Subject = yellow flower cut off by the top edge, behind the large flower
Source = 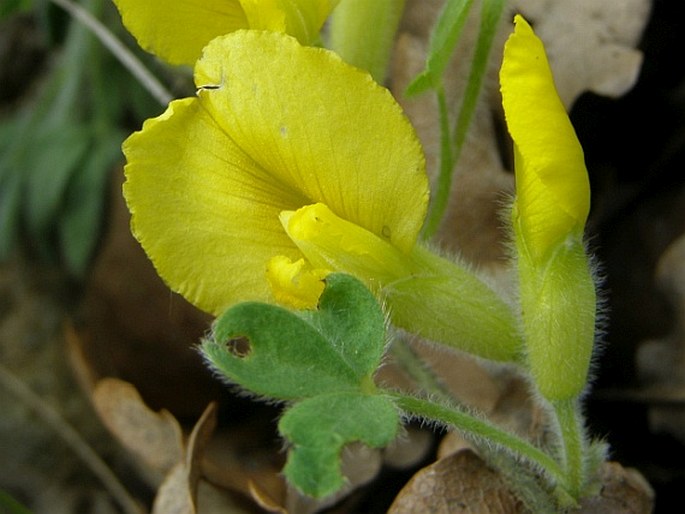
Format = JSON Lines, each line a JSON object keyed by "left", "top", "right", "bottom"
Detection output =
{"left": 114, "top": 0, "right": 339, "bottom": 65}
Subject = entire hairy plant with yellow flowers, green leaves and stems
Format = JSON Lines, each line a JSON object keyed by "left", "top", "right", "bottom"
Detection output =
{"left": 116, "top": 0, "right": 604, "bottom": 507}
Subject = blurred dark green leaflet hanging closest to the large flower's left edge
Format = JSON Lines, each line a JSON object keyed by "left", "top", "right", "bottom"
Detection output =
{"left": 58, "top": 131, "right": 123, "bottom": 277}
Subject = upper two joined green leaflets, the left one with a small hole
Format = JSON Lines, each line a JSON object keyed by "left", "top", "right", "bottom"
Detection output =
{"left": 201, "top": 274, "right": 385, "bottom": 400}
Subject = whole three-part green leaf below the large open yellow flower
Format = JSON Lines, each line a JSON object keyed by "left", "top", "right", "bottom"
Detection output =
{"left": 202, "top": 273, "right": 400, "bottom": 497}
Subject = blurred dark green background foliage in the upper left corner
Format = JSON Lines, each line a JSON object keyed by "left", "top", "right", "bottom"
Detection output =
{"left": 0, "top": 0, "right": 162, "bottom": 278}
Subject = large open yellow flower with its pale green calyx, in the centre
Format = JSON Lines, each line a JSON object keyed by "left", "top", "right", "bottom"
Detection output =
{"left": 124, "top": 31, "right": 520, "bottom": 360}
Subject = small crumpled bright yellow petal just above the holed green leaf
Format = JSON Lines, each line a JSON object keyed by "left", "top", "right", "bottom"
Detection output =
{"left": 266, "top": 255, "right": 328, "bottom": 309}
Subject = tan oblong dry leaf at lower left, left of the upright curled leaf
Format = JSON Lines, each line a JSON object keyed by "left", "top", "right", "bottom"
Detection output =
{"left": 93, "top": 378, "right": 184, "bottom": 484}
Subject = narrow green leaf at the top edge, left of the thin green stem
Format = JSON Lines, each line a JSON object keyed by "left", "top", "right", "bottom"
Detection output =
{"left": 406, "top": 0, "right": 473, "bottom": 96}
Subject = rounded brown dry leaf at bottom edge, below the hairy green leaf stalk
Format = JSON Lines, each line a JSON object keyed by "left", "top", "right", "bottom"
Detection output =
{"left": 388, "top": 449, "right": 524, "bottom": 514}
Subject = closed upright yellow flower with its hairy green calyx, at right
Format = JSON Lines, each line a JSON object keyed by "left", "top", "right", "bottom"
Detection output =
{"left": 500, "top": 16, "right": 596, "bottom": 401}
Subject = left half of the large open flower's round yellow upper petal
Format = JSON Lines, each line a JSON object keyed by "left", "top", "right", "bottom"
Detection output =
{"left": 124, "top": 99, "right": 302, "bottom": 313}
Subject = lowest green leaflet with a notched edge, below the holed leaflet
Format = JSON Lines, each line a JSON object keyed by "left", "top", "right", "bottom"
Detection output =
{"left": 278, "top": 392, "right": 399, "bottom": 498}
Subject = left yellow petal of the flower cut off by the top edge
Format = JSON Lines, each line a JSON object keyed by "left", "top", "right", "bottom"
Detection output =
{"left": 114, "top": 0, "right": 248, "bottom": 65}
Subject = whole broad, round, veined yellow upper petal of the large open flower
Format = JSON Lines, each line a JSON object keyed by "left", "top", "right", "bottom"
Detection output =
{"left": 124, "top": 31, "right": 427, "bottom": 314}
